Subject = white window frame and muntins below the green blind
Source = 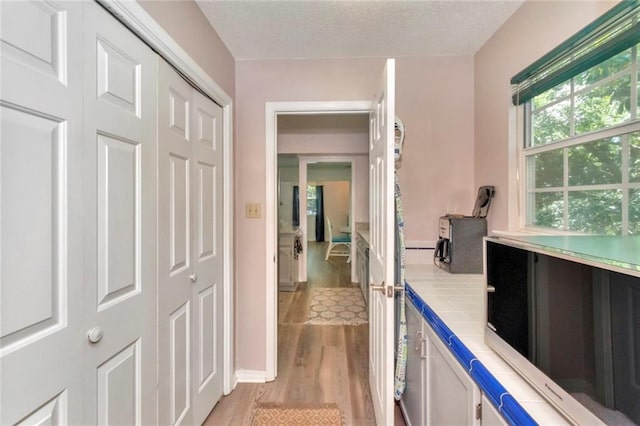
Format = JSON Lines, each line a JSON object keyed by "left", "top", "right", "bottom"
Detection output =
{"left": 510, "top": 45, "right": 640, "bottom": 235}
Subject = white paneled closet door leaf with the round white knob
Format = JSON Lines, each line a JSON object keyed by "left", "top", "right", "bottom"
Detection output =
{"left": 83, "top": 2, "right": 157, "bottom": 425}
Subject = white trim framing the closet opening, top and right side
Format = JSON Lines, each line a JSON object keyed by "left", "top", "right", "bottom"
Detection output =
{"left": 96, "top": 0, "right": 237, "bottom": 395}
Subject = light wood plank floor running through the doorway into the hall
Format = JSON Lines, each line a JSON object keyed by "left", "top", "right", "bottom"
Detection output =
{"left": 204, "top": 243, "right": 405, "bottom": 426}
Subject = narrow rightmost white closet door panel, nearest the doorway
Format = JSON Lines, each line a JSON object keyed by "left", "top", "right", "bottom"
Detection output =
{"left": 191, "top": 90, "right": 223, "bottom": 424}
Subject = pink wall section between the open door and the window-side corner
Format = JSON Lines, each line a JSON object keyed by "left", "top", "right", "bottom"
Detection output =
{"left": 396, "top": 56, "right": 476, "bottom": 243}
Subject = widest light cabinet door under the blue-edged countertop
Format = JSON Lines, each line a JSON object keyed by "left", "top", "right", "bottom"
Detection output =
{"left": 425, "top": 326, "right": 480, "bottom": 426}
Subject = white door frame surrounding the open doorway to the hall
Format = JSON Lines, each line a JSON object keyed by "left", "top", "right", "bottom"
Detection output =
{"left": 264, "top": 101, "right": 371, "bottom": 381}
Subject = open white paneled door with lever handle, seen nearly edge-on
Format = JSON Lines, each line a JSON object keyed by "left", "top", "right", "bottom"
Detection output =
{"left": 369, "top": 59, "right": 395, "bottom": 425}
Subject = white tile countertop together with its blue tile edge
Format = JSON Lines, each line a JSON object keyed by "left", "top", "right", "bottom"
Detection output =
{"left": 405, "top": 264, "right": 568, "bottom": 425}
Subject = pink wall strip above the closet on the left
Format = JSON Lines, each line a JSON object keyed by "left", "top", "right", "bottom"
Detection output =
{"left": 138, "top": 0, "right": 235, "bottom": 98}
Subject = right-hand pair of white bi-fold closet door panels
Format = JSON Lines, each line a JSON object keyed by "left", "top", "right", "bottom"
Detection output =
{"left": 158, "top": 60, "right": 223, "bottom": 424}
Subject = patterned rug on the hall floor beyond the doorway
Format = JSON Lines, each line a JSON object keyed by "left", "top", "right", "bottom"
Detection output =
{"left": 305, "top": 287, "right": 369, "bottom": 325}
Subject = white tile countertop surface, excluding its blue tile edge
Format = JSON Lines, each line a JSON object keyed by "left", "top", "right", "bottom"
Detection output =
{"left": 405, "top": 264, "right": 568, "bottom": 425}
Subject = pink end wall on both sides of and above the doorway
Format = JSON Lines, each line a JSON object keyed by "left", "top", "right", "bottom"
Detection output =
{"left": 235, "top": 57, "right": 475, "bottom": 370}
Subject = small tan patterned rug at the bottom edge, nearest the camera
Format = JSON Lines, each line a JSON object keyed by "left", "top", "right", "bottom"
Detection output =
{"left": 251, "top": 402, "right": 343, "bottom": 426}
